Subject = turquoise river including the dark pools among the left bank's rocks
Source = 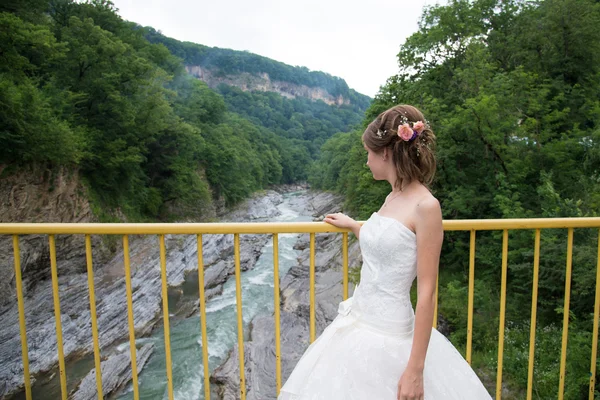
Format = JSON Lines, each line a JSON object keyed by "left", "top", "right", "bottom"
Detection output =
{"left": 10, "top": 191, "right": 312, "bottom": 400}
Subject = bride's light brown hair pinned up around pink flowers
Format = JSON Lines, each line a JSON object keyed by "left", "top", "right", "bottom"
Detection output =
{"left": 362, "top": 104, "right": 436, "bottom": 189}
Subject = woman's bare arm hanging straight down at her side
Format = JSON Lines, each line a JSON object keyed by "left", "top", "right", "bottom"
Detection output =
{"left": 398, "top": 197, "right": 444, "bottom": 399}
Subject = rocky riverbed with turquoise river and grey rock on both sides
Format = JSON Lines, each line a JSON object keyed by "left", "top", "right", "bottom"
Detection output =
{"left": 0, "top": 191, "right": 358, "bottom": 399}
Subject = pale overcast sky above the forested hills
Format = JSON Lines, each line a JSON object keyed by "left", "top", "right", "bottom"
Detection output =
{"left": 112, "top": 0, "right": 445, "bottom": 97}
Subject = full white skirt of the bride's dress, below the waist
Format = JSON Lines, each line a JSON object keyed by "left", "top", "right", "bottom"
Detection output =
{"left": 278, "top": 299, "right": 491, "bottom": 400}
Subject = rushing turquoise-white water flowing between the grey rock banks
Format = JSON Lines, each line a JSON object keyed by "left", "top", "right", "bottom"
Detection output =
{"left": 119, "top": 193, "right": 311, "bottom": 400}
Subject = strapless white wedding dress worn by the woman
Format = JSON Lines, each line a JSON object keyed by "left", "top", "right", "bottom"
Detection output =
{"left": 278, "top": 213, "right": 491, "bottom": 400}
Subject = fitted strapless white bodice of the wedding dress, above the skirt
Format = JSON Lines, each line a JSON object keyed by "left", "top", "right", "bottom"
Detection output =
{"left": 352, "top": 213, "right": 417, "bottom": 332}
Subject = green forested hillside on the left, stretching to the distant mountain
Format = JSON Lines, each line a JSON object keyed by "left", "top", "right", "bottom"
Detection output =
{"left": 0, "top": 0, "right": 369, "bottom": 221}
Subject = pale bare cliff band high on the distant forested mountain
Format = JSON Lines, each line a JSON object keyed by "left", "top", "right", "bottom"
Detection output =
{"left": 185, "top": 65, "right": 350, "bottom": 106}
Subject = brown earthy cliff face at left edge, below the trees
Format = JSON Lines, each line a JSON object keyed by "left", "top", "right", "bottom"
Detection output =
{"left": 0, "top": 165, "right": 108, "bottom": 306}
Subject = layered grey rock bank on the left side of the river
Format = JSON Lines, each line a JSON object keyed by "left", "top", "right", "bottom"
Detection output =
{"left": 0, "top": 189, "right": 310, "bottom": 398}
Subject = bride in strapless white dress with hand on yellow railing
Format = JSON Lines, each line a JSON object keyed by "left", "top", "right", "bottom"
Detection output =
{"left": 278, "top": 105, "right": 491, "bottom": 400}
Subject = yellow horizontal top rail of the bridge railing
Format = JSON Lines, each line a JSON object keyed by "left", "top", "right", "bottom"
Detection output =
{"left": 0, "top": 217, "right": 600, "bottom": 235}
